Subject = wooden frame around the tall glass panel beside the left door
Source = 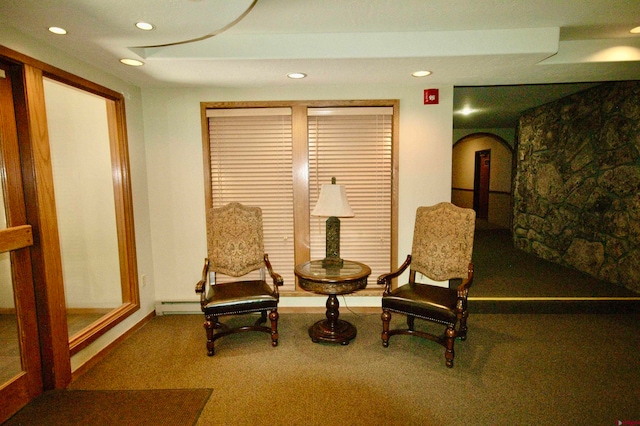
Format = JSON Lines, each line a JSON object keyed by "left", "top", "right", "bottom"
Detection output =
{"left": 0, "top": 45, "right": 140, "bottom": 398}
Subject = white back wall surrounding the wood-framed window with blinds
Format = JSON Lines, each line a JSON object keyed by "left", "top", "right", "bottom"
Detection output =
{"left": 143, "top": 86, "right": 453, "bottom": 306}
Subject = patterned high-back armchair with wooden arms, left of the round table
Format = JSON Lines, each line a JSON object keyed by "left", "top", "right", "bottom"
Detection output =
{"left": 196, "top": 203, "right": 283, "bottom": 356}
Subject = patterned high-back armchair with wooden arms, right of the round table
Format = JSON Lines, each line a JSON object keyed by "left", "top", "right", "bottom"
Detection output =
{"left": 378, "top": 203, "right": 475, "bottom": 367}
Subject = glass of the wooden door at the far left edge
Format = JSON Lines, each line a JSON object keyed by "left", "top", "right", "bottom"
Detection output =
{"left": 0, "top": 181, "right": 22, "bottom": 385}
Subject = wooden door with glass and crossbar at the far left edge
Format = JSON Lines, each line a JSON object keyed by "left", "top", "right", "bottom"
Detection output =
{"left": 0, "top": 62, "right": 43, "bottom": 423}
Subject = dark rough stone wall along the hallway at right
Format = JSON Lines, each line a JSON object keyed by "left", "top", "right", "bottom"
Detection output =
{"left": 513, "top": 81, "right": 640, "bottom": 293}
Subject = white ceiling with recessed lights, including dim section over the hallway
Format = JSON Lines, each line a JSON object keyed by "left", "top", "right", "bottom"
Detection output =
{"left": 0, "top": 0, "right": 640, "bottom": 128}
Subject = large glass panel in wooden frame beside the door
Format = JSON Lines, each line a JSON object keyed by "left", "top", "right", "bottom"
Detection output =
{"left": 44, "top": 79, "right": 123, "bottom": 336}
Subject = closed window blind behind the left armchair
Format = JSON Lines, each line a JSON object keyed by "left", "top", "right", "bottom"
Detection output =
{"left": 207, "top": 108, "right": 295, "bottom": 290}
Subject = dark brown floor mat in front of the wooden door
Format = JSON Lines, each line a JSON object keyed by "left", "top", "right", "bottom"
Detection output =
{"left": 5, "top": 389, "right": 211, "bottom": 426}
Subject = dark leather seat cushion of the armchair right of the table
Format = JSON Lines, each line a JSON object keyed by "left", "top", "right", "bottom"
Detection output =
{"left": 382, "top": 283, "right": 458, "bottom": 324}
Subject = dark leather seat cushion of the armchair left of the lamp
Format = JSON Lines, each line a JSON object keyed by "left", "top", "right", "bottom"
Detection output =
{"left": 204, "top": 281, "right": 278, "bottom": 315}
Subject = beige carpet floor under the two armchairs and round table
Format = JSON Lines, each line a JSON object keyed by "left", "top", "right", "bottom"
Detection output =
{"left": 61, "top": 312, "right": 640, "bottom": 426}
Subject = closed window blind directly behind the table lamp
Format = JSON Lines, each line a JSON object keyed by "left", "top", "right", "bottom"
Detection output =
{"left": 308, "top": 107, "right": 393, "bottom": 282}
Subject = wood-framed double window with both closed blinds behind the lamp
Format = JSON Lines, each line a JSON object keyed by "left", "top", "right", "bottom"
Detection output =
{"left": 202, "top": 101, "right": 397, "bottom": 291}
